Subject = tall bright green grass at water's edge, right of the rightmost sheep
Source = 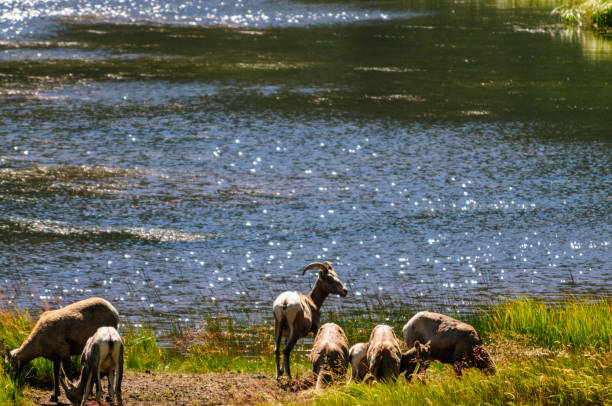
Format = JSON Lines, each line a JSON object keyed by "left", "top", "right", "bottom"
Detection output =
{"left": 479, "top": 297, "right": 612, "bottom": 351}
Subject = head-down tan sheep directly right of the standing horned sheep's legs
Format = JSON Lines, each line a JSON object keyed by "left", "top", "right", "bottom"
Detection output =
{"left": 310, "top": 323, "right": 348, "bottom": 389}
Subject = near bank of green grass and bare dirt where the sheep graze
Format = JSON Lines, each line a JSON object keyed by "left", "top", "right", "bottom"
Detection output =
{"left": 0, "top": 297, "right": 612, "bottom": 405}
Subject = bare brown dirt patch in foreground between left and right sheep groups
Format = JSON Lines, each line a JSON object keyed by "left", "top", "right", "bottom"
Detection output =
{"left": 24, "top": 371, "right": 312, "bottom": 406}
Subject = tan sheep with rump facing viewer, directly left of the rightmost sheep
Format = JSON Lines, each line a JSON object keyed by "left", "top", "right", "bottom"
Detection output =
{"left": 366, "top": 324, "right": 402, "bottom": 381}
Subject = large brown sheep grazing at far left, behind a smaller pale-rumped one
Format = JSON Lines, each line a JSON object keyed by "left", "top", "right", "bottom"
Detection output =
{"left": 6, "top": 297, "right": 119, "bottom": 402}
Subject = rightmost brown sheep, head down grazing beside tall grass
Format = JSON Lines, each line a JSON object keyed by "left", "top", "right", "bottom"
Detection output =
{"left": 402, "top": 312, "right": 495, "bottom": 376}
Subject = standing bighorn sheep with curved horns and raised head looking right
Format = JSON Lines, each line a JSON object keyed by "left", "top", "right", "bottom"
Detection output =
{"left": 272, "top": 262, "right": 348, "bottom": 379}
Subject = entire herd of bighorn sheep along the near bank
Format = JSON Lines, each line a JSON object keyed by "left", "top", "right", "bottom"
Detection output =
{"left": 1, "top": 262, "right": 495, "bottom": 406}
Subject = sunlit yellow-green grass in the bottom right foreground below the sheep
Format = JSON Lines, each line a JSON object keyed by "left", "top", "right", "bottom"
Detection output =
{"left": 313, "top": 353, "right": 612, "bottom": 406}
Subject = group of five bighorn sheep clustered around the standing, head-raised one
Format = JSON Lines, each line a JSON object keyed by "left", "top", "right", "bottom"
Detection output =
{"left": 272, "top": 262, "right": 495, "bottom": 388}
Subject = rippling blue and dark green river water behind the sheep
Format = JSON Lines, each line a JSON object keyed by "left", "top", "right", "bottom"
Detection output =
{"left": 0, "top": 0, "right": 612, "bottom": 325}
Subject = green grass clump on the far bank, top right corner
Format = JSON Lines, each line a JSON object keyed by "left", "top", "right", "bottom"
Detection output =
{"left": 553, "top": 0, "right": 612, "bottom": 30}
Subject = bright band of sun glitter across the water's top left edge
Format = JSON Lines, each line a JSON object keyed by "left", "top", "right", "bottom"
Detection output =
{"left": 0, "top": 0, "right": 417, "bottom": 39}
